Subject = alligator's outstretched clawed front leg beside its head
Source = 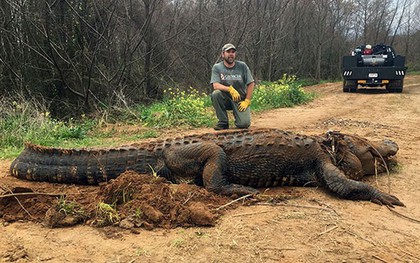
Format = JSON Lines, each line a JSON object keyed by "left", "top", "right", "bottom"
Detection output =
{"left": 318, "top": 162, "right": 404, "bottom": 207}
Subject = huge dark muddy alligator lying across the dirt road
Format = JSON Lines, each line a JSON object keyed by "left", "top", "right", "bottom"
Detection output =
{"left": 10, "top": 129, "right": 404, "bottom": 206}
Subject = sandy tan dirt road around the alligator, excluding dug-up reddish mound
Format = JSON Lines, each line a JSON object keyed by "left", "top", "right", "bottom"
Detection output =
{"left": 0, "top": 76, "right": 420, "bottom": 262}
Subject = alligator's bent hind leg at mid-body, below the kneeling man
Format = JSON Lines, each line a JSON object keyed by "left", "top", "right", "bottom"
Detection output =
{"left": 165, "top": 141, "right": 258, "bottom": 196}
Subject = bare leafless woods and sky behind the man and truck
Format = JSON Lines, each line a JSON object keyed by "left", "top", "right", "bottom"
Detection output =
{"left": 0, "top": 0, "right": 420, "bottom": 119}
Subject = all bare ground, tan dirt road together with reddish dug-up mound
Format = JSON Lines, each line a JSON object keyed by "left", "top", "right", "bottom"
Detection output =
{"left": 0, "top": 76, "right": 420, "bottom": 262}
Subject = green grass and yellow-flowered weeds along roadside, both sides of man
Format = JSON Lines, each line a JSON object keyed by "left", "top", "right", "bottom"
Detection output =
{"left": 0, "top": 75, "right": 315, "bottom": 159}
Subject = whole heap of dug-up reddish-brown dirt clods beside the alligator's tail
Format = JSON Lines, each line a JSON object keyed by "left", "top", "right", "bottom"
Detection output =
{"left": 0, "top": 171, "right": 235, "bottom": 229}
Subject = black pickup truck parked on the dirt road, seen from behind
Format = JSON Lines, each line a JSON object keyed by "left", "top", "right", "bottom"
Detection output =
{"left": 342, "top": 44, "right": 407, "bottom": 93}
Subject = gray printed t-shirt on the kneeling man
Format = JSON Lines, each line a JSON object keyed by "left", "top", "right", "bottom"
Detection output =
{"left": 210, "top": 60, "right": 254, "bottom": 99}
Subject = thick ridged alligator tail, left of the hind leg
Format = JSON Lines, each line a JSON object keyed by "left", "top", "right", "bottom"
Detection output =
{"left": 10, "top": 143, "right": 160, "bottom": 184}
